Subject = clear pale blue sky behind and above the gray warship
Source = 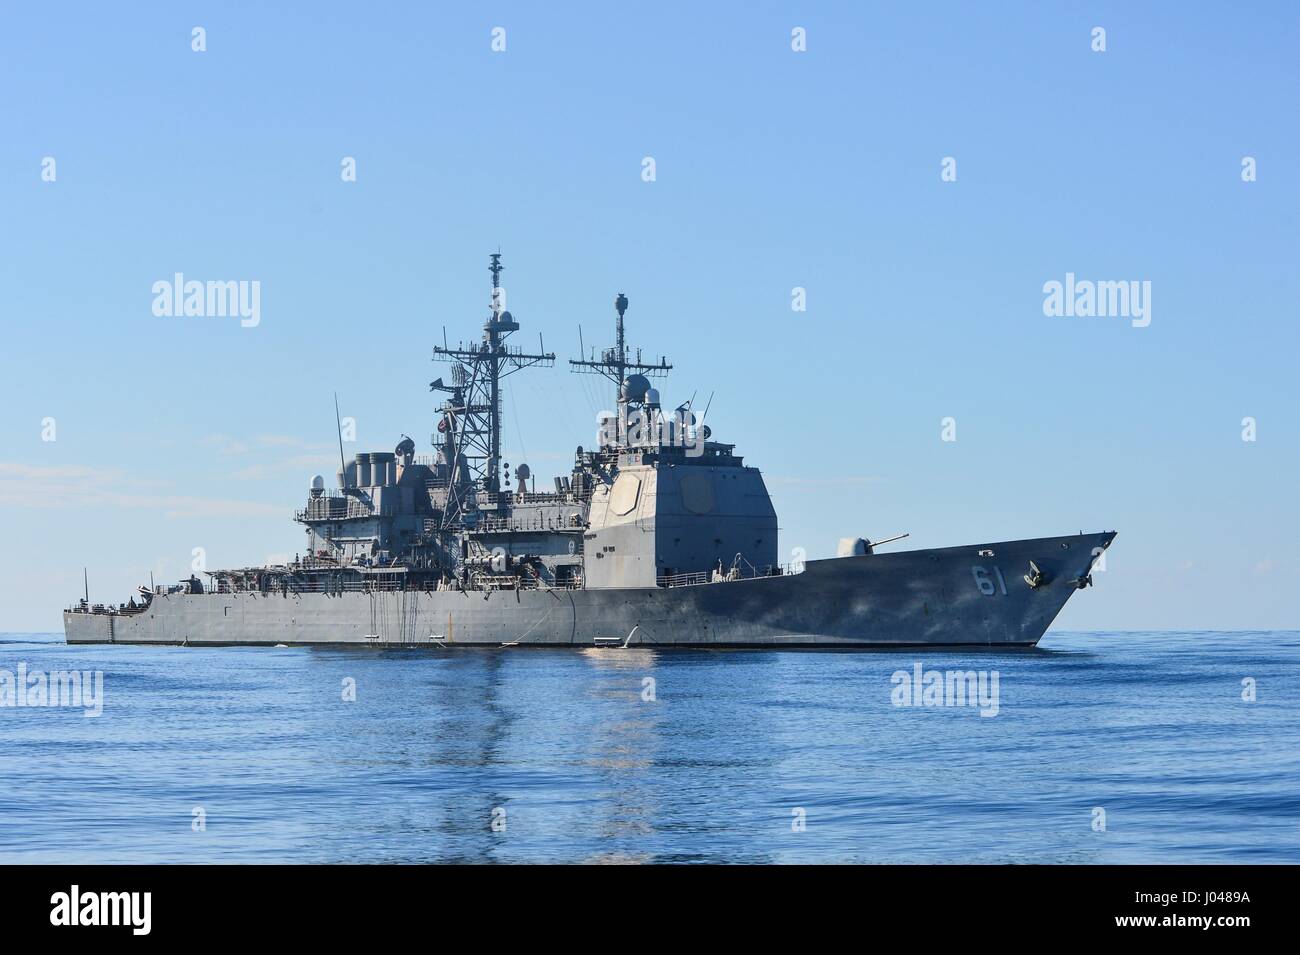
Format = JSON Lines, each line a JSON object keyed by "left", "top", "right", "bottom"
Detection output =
{"left": 0, "top": 3, "right": 1300, "bottom": 630}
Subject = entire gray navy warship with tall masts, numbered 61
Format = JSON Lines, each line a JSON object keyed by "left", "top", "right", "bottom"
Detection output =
{"left": 64, "top": 253, "right": 1115, "bottom": 648}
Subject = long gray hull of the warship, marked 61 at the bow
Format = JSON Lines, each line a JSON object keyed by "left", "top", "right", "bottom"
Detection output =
{"left": 64, "top": 533, "right": 1114, "bottom": 647}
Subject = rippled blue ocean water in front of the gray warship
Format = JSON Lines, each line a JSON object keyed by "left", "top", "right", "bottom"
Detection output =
{"left": 0, "top": 631, "right": 1300, "bottom": 863}
